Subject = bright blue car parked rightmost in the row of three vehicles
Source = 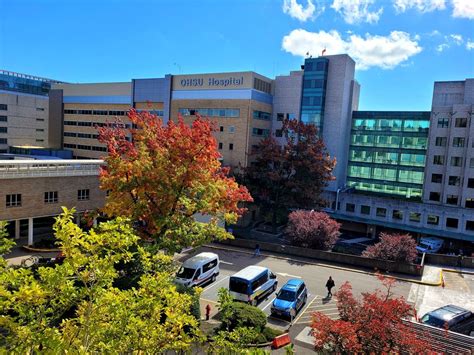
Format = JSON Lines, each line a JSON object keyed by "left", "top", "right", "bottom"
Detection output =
{"left": 271, "top": 279, "right": 308, "bottom": 318}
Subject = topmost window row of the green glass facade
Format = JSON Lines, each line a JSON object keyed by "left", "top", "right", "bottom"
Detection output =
{"left": 352, "top": 118, "right": 430, "bottom": 132}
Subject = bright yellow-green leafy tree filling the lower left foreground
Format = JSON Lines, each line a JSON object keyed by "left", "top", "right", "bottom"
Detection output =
{"left": 0, "top": 209, "right": 202, "bottom": 354}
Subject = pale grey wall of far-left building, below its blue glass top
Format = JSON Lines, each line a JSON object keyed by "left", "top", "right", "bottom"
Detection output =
{"left": 0, "top": 93, "right": 49, "bottom": 151}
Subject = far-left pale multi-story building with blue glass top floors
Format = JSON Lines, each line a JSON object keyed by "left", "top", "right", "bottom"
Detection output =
{"left": 0, "top": 70, "right": 62, "bottom": 153}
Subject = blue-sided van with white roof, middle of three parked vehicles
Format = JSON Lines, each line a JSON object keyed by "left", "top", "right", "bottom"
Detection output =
{"left": 229, "top": 265, "right": 278, "bottom": 306}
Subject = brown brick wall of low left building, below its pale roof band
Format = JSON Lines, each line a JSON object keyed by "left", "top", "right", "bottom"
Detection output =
{"left": 0, "top": 176, "right": 106, "bottom": 221}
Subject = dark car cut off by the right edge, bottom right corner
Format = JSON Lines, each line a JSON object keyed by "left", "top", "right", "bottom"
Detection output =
{"left": 420, "top": 304, "right": 474, "bottom": 335}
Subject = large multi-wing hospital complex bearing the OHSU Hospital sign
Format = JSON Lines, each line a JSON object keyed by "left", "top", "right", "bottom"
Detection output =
{"left": 34, "top": 55, "right": 474, "bottom": 246}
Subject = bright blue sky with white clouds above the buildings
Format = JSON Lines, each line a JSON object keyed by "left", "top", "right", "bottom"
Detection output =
{"left": 0, "top": 0, "right": 474, "bottom": 110}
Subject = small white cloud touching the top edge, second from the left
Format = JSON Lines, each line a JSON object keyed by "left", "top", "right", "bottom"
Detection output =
{"left": 331, "top": 0, "right": 383, "bottom": 24}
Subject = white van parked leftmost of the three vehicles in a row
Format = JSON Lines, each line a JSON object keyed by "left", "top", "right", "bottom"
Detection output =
{"left": 175, "top": 253, "right": 219, "bottom": 287}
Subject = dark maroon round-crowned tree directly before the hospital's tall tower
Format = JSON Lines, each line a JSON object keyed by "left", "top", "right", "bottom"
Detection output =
{"left": 242, "top": 120, "right": 336, "bottom": 232}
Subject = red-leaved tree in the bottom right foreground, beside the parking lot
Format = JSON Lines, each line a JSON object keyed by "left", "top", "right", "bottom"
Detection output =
{"left": 311, "top": 276, "right": 430, "bottom": 354}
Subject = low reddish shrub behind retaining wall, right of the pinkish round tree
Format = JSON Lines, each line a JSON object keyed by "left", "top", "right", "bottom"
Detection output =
{"left": 362, "top": 233, "right": 417, "bottom": 263}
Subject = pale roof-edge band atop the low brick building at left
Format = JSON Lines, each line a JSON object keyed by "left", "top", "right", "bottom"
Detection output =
{"left": 0, "top": 159, "right": 104, "bottom": 179}
